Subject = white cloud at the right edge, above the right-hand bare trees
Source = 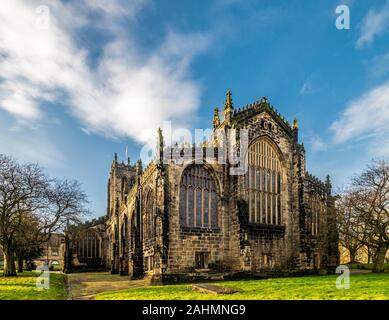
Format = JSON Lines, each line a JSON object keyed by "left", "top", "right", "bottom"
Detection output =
{"left": 330, "top": 83, "right": 389, "bottom": 143}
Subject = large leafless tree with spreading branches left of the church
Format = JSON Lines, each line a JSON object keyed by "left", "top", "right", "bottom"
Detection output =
{"left": 0, "top": 155, "right": 88, "bottom": 276}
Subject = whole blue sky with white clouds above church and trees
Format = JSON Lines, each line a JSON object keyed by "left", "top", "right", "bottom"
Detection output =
{"left": 0, "top": 0, "right": 389, "bottom": 216}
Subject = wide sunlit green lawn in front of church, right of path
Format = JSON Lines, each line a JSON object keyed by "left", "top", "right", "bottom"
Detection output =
{"left": 96, "top": 273, "right": 389, "bottom": 300}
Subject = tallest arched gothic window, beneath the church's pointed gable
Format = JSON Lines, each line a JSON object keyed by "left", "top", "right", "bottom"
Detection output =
{"left": 245, "top": 139, "right": 282, "bottom": 224}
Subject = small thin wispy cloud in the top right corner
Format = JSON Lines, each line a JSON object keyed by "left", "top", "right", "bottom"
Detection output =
{"left": 356, "top": 1, "right": 389, "bottom": 48}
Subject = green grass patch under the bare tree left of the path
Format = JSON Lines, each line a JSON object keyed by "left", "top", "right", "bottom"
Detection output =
{"left": 0, "top": 271, "right": 67, "bottom": 300}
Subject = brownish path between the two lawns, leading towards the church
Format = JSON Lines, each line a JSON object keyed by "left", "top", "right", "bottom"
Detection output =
{"left": 68, "top": 272, "right": 148, "bottom": 300}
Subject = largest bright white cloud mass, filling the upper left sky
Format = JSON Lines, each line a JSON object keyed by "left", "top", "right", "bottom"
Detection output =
{"left": 0, "top": 0, "right": 210, "bottom": 142}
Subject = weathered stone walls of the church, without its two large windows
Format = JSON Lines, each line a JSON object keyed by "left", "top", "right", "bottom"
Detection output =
{"left": 106, "top": 95, "right": 338, "bottom": 283}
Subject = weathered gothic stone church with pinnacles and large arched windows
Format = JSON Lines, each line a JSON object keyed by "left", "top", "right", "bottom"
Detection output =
{"left": 66, "top": 92, "right": 339, "bottom": 283}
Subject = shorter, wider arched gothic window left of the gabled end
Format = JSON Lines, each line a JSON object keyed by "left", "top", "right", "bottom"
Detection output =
{"left": 180, "top": 164, "right": 218, "bottom": 228}
